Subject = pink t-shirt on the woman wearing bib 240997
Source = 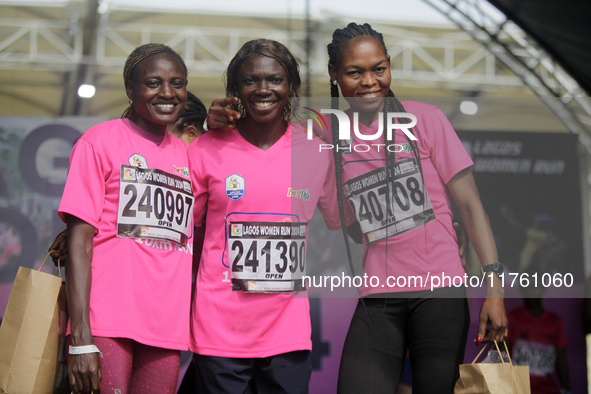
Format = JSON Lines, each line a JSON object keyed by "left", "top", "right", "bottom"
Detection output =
{"left": 59, "top": 119, "right": 193, "bottom": 350}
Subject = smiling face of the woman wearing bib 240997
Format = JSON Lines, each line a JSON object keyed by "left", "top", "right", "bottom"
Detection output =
{"left": 126, "top": 54, "right": 187, "bottom": 135}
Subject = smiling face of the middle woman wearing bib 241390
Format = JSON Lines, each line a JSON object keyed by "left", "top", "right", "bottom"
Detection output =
{"left": 238, "top": 56, "right": 289, "bottom": 123}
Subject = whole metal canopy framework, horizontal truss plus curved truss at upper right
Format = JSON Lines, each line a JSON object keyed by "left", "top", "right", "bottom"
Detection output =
{"left": 0, "top": 0, "right": 591, "bottom": 152}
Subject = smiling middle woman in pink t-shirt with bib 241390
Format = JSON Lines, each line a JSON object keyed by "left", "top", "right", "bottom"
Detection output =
{"left": 189, "top": 39, "right": 338, "bottom": 394}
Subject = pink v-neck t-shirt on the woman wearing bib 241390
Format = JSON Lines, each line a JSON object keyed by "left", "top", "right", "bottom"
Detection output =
{"left": 189, "top": 127, "right": 338, "bottom": 358}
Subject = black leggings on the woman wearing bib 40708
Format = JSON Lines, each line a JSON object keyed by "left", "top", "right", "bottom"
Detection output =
{"left": 338, "top": 288, "right": 470, "bottom": 394}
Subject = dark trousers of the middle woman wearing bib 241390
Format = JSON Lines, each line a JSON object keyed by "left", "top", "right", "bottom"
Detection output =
{"left": 193, "top": 351, "right": 312, "bottom": 394}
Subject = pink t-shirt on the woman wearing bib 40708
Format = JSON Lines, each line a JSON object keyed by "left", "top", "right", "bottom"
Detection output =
{"left": 323, "top": 101, "right": 473, "bottom": 296}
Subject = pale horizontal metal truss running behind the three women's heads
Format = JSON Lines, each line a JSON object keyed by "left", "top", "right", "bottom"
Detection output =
{"left": 0, "top": 18, "right": 522, "bottom": 86}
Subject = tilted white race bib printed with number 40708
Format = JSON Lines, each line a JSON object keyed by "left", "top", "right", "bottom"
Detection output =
{"left": 344, "top": 158, "right": 435, "bottom": 244}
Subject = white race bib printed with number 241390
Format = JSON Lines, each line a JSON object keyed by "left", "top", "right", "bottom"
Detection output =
{"left": 228, "top": 222, "right": 308, "bottom": 293}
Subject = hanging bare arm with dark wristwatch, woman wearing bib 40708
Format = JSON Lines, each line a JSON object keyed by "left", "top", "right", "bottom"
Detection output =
{"left": 447, "top": 168, "right": 507, "bottom": 344}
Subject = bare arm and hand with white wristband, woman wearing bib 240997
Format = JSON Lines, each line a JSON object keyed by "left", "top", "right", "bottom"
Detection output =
{"left": 66, "top": 215, "right": 102, "bottom": 393}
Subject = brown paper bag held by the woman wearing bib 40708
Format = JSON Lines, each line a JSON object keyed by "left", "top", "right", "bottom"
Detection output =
{"left": 454, "top": 341, "right": 531, "bottom": 394}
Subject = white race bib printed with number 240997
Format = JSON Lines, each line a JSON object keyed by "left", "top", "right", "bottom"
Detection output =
{"left": 117, "top": 165, "right": 193, "bottom": 246}
